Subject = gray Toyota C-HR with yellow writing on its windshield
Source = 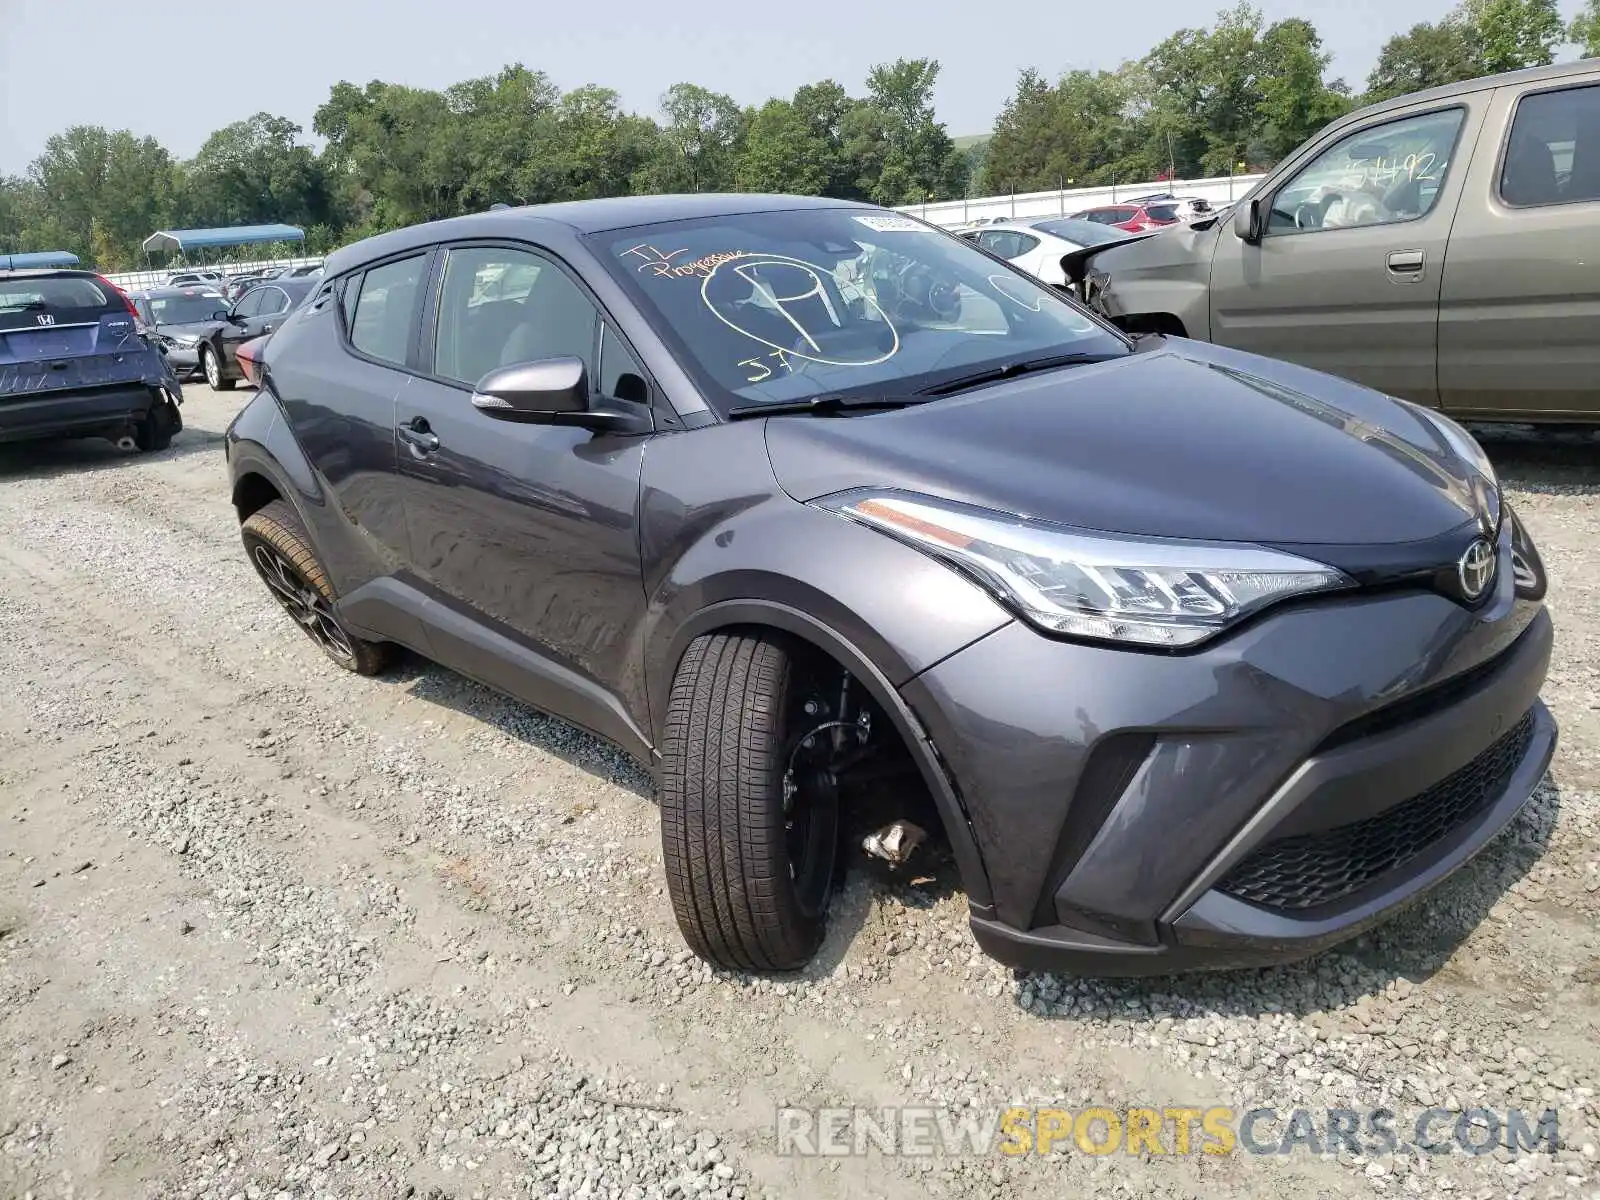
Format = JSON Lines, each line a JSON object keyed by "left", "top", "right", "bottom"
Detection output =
{"left": 227, "top": 195, "right": 1555, "bottom": 974}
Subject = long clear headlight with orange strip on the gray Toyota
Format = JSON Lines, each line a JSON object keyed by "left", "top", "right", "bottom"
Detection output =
{"left": 813, "top": 490, "right": 1354, "bottom": 648}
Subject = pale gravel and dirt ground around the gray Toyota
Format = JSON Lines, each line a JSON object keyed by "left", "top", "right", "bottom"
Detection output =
{"left": 0, "top": 387, "right": 1600, "bottom": 1200}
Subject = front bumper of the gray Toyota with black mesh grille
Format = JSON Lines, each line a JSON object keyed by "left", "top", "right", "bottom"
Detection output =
{"left": 902, "top": 523, "right": 1557, "bottom": 976}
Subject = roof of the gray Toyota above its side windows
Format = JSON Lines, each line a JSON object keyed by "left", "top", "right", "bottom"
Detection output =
{"left": 323, "top": 192, "right": 878, "bottom": 277}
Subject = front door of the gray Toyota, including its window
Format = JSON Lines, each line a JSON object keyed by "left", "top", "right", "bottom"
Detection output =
{"left": 395, "top": 245, "right": 648, "bottom": 742}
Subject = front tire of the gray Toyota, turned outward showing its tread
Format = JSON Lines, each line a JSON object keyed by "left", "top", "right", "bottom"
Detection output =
{"left": 661, "top": 634, "right": 838, "bottom": 971}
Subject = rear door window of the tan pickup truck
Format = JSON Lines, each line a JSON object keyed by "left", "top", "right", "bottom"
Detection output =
{"left": 1499, "top": 85, "right": 1600, "bottom": 208}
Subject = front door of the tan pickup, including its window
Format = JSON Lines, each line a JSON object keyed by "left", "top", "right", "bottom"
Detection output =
{"left": 1211, "top": 101, "right": 1482, "bottom": 406}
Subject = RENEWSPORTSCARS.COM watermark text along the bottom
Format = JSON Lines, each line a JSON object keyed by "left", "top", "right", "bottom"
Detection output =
{"left": 776, "top": 1106, "right": 1560, "bottom": 1157}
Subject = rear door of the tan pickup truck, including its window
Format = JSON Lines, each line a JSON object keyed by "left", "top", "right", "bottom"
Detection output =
{"left": 1438, "top": 75, "right": 1600, "bottom": 421}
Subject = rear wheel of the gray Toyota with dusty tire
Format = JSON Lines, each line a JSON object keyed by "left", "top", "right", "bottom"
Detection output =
{"left": 240, "top": 499, "right": 395, "bottom": 675}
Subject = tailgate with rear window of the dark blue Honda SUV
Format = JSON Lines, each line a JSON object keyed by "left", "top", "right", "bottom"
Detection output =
{"left": 0, "top": 272, "right": 150, "bottom": 400}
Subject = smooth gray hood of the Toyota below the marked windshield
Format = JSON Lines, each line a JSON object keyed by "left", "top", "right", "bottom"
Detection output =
{"left": 766, "top": 339, "right": 1498, "bottom": 547}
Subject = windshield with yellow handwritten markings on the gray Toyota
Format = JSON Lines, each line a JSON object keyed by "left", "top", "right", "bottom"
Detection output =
{"left": 602, "top": 208, "right": 1126, "bottom": 413}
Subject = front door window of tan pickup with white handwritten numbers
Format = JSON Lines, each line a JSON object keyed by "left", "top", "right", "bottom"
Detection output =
{"left": 1267, "top": 109, "right": 1464, "bottom": 234}
